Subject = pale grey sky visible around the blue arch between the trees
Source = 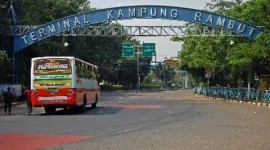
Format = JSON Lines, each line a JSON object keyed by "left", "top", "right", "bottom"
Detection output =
{"left": 90, "top": 0, "right": 210, "bottom": 61}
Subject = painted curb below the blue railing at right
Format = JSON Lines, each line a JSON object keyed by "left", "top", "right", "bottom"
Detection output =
{"left": 194, "top": 94, "right": 270, "bottom": 109}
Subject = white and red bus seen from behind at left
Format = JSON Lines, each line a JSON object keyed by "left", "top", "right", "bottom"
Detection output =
{"left": 31, "top": 56, "right": 100, "bottom": 114}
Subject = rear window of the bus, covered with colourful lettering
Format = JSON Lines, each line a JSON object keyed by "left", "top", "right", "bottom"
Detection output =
{"left": 34, "top": 58, "right": 72, "bottom": 74}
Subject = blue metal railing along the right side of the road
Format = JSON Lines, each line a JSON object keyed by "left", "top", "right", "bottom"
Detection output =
{"left": 195, "top": 87, "right": 270, "bottom": 103}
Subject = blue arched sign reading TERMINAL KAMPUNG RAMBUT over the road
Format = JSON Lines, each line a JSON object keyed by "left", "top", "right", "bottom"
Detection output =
{"left": 14, "top": 5, "right": 263, "bottom": 52}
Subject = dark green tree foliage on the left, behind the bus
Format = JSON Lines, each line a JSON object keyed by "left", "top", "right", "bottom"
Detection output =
{"left": 0, "top": 0, "right": 151, "bottom": 85}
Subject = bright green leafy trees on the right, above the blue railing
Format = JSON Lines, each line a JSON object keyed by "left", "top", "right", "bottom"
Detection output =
{"left": 171, "top": 0, "right": 270, "bottom": 87}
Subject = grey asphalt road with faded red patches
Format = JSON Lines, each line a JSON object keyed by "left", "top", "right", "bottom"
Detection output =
{"left": 0, "top": 91, "right": 270, "bottom": 150}
